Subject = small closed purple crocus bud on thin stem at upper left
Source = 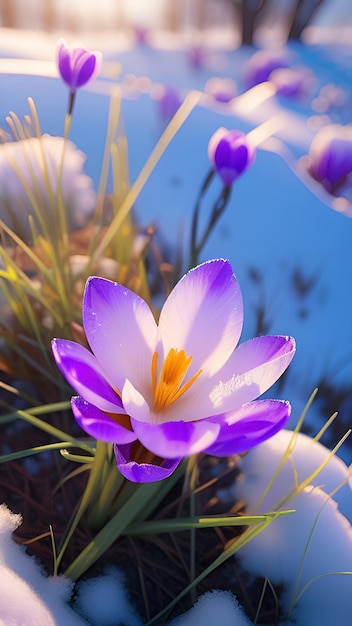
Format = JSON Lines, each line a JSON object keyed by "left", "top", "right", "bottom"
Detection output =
{"left": 56, "top": 38, "right": 102, "bottom": 93}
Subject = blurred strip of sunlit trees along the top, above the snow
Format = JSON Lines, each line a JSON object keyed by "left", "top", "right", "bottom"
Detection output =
{"left": 0, "top": 0, "right": 352, "bottom": 44}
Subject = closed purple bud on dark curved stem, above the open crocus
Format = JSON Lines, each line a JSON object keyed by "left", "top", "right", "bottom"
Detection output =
{"left": 208, "top": 128, "right": 256, "bottom": 187}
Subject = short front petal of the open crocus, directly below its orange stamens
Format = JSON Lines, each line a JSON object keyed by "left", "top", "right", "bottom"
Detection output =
{"left": 131, "top": 418, "right": 220, "bottom": 459}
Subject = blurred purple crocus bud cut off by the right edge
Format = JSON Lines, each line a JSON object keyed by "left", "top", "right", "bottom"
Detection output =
{"left": 307, "top": 124, "right": 352, "bottom": 195}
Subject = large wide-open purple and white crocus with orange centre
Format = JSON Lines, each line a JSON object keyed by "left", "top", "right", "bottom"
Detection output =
{"left": 53, "top": 259, "right": 295, "bottom": 482}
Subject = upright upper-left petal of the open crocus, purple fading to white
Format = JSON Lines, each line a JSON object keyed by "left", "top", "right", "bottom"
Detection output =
{"left": 83, "top": 277, "right": 158, "bottom": 393}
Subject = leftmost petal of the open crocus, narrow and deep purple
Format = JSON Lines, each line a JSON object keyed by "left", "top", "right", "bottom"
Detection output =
{"left": 51, "top": 339, "right": 125, "bottom": 413}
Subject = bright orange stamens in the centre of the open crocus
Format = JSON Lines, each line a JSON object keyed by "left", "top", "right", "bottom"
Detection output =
{"left": 152, "top": 348, "right": 202, "bottom": 411}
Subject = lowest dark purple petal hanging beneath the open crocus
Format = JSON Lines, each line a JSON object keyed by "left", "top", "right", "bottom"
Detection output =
{"left": 114, "top": 444, "right": 182, "bottom": 483}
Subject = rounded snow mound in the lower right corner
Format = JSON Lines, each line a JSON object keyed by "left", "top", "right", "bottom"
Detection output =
{"left": 233, "top": 430, "right": 352, "bottom": 626}
